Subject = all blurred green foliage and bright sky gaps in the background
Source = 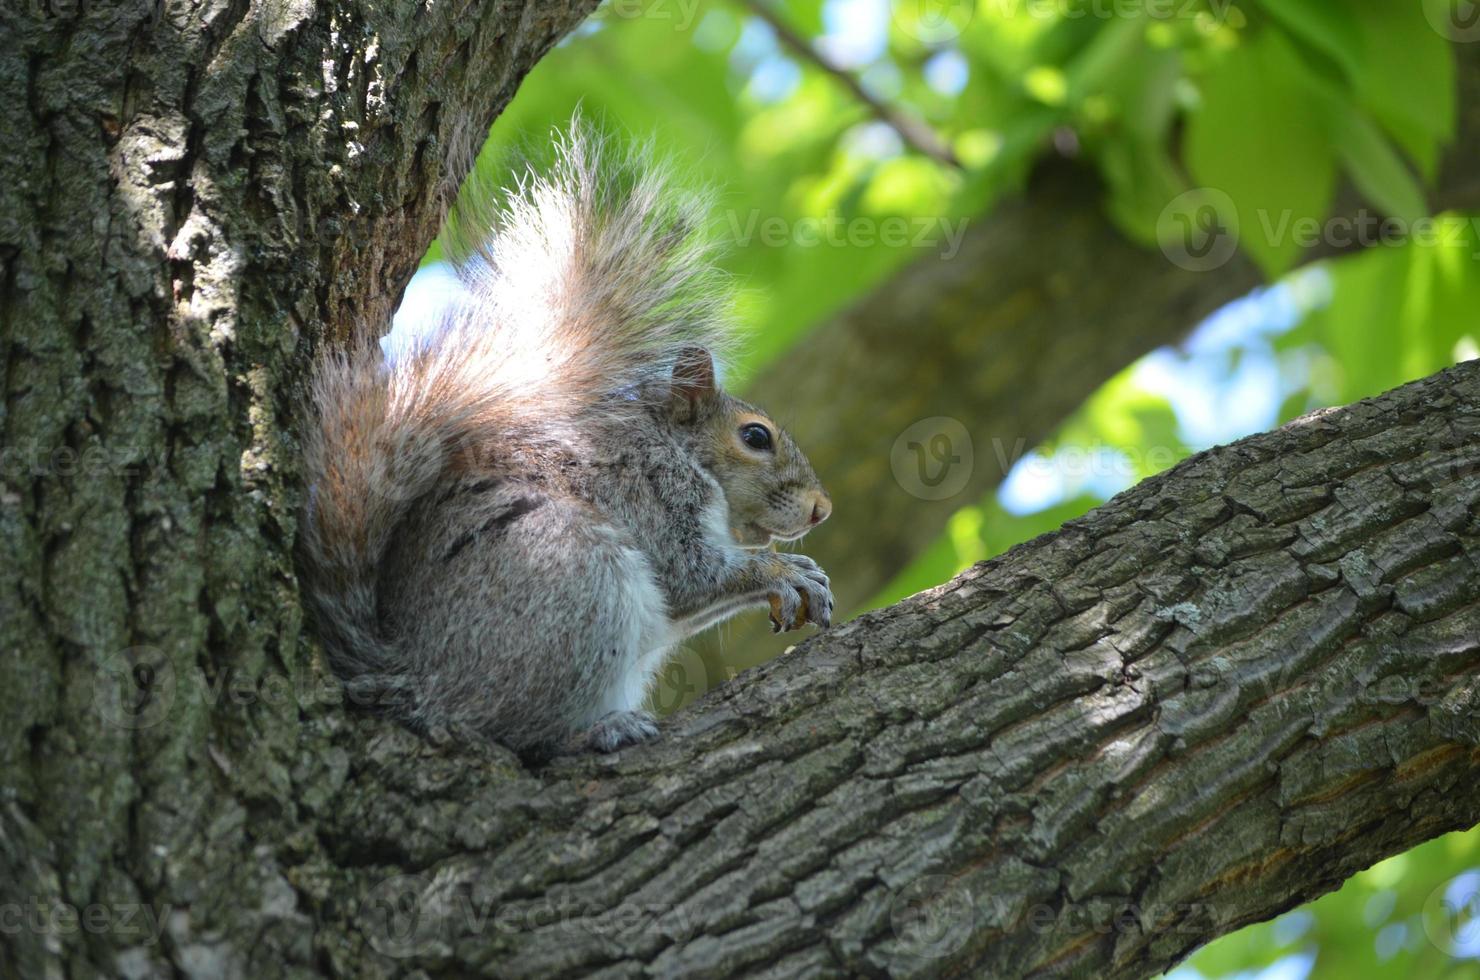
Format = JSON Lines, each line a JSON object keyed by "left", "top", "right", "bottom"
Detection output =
{"left": 428, "top": 0, "right": 1480, "bottom": 980}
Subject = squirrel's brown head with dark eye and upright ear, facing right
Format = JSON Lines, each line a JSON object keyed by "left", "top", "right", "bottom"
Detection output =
{"left": 669, "top": 348, "right": 832, "bottom": 548}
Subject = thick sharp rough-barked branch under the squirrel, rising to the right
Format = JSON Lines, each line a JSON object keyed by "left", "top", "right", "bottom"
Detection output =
{"left": 303, "top": 363, "right": 1480, "bottom": 977}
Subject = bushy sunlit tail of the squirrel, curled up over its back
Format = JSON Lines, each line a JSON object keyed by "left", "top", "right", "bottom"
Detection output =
{"left": 303, "top": 121, "right": 727, "bottom": 714}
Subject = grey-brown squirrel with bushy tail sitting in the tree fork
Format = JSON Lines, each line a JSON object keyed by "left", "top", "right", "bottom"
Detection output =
{"left": 300, "top": 120, "right": 833, "bottom": 754}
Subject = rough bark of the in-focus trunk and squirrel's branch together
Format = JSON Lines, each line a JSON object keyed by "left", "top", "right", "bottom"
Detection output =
{"left": 0, "top": 3, "right": 1480, "bottom": 977}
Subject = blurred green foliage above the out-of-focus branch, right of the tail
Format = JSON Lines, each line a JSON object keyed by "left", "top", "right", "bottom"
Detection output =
{"left": 455, "top": 0, "right": 1465, "bottom": 375}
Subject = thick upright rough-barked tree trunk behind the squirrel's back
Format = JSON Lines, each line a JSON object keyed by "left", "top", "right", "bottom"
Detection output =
{"left": 0, "top": 0, "right": 596, "bottom": 977}
